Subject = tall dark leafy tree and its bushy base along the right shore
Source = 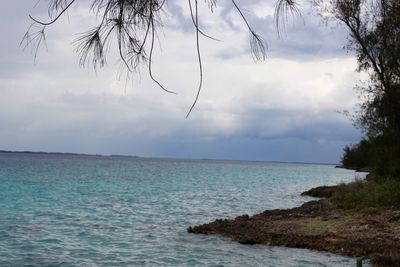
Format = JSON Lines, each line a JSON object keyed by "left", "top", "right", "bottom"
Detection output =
{"left": 331, "top": 0, "right": 400, "bottom": 176}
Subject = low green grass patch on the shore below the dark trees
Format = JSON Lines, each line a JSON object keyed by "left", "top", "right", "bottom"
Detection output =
{"left": 331, "top": 178, "right": 400, "bottom": 210}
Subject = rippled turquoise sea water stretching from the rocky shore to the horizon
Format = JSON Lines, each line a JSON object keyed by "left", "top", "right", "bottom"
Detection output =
{"left": 0, "top": 153, "right": 362, "bottom": 266}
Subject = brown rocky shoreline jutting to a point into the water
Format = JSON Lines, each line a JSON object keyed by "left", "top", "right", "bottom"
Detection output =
{"left": 188, "top": 186, "right": 400, "bottom": 266}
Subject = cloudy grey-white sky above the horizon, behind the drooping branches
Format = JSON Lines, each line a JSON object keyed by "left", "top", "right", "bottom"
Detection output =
{"left": 0, "top": 0, "right": 363, "bottom": 163}
